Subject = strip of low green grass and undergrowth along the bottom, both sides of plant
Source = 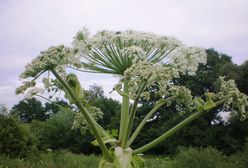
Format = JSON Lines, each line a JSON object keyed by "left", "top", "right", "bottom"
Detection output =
{"left": 0, "top": 145, "right": 248, "bottom": 168}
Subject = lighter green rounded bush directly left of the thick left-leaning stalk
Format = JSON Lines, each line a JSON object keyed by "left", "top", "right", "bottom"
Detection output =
{"left": 30, "top": 109, "right": 99, "bottom": 154}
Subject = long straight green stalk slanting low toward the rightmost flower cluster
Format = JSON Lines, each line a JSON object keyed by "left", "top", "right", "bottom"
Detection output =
{"left": 133, "top": 99, "right": 227, "bottom": 154}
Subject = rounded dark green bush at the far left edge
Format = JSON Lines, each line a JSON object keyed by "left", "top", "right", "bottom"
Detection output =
{"left": 0, "top": 115, "right": 36, "bottom": 157}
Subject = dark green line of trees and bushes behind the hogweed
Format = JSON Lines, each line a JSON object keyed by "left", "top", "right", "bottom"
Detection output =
{"left": 0, "top": 49, "right": 248, "bottom": 157}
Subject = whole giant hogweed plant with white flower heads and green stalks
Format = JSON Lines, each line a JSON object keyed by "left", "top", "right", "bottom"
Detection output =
{"left": 16, "top": 29, "right": 248, "bottom": 168}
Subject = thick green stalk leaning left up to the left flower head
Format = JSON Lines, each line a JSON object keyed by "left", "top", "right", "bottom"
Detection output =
{"left": 51, "top": 70, "right": 113, "bottom": 162}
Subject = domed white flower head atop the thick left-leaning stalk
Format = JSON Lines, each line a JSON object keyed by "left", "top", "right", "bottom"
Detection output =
{"left": 20, "top": 45, "right": 79, "bottom": 79}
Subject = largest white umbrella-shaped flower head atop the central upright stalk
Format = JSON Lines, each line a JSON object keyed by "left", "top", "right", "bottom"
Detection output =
{"left": 73, "top": 29, "right": 182, "bottom": 75}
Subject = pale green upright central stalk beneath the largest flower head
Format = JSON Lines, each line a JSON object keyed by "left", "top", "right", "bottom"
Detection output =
{"left": 119, "top": 81, "right": 129, "bottom": 147}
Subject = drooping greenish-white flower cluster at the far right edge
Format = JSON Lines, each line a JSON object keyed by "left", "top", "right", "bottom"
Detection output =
{"left": 216, "top": 77, "right": 248, "bottom": 120}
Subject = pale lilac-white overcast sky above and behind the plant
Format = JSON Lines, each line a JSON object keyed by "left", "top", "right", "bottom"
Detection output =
{"left": 0, "top": 0, "right": 248, "bottom": 108}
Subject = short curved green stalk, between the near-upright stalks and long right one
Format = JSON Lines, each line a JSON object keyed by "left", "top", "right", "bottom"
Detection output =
{"left": 127, "top": 101, "right": 166, "bottom": 146}
